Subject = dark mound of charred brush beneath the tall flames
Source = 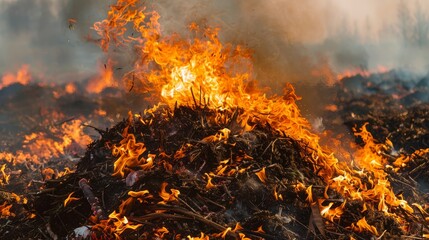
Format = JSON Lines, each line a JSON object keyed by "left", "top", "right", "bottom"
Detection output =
{"left": 0, "top": 102, "right": 416, "bottom": 239}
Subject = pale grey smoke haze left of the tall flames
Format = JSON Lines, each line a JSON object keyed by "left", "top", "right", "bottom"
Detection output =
{"left": 0, "top": 0, "right": 100, "bottom": 82}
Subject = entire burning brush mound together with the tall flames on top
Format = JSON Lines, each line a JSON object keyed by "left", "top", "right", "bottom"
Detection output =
{"left": 0, "top": 0, "right": 429, "bottom": 239}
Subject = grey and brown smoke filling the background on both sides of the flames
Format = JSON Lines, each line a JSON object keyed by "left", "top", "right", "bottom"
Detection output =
{"left": 0, "top": 0, "right": 429, "bottom": 87}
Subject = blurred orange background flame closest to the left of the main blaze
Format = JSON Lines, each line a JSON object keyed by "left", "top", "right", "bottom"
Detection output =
{"left": 86, "top": 60, "right": 118, "bottom": 93}
